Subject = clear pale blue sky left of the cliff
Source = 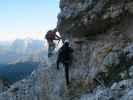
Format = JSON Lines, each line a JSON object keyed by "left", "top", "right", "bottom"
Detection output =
{"left": 0, "top": 0, "right": 59, "bottom": 41}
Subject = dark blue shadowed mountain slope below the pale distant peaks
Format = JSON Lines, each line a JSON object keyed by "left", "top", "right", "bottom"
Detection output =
{"left": 0, "top": 62, "right": 39, "bottom": 83}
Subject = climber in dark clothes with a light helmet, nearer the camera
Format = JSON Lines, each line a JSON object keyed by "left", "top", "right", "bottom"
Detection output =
{"left": 57, "top": 40, "right": 73, "bottom": 86}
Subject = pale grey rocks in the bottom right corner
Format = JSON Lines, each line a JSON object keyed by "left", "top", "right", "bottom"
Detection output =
{"left": 80, "top": 80, "right": 133, "bottom": 100}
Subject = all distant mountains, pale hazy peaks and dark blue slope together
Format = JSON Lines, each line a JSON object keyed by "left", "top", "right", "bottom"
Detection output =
{"left": 0, "top": 39, "right": 47, "bottom": 83}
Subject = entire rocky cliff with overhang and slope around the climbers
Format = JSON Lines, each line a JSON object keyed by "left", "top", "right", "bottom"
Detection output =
{"left": 0, "top": 0, "right": 133, "bottom": 100}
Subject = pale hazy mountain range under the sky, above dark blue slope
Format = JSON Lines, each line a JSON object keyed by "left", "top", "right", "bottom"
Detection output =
{"left": 0, "top": 39, "right": 47, "bottom": 64}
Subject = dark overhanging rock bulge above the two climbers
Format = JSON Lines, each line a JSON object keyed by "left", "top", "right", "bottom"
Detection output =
{"left": 57, "top": 0, "right": 133, "bottom": 37}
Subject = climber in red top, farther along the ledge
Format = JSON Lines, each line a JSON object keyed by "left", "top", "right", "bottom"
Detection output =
{"left": 45, "top": 28, "right": 61, "bottom": 57}
